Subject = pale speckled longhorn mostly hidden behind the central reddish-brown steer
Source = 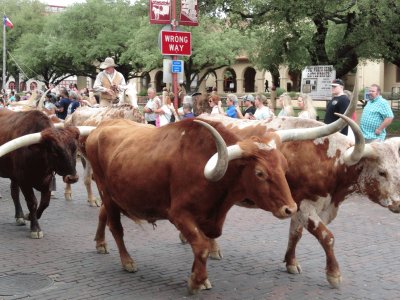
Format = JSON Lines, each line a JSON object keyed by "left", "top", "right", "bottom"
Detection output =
{"left": 64, "top": 104, "right": 144, "bottom": 207}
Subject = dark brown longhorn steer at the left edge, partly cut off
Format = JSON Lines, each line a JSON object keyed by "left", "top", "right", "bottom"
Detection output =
{"left": 0, "top": 109, "right": 91, "bottom": 238}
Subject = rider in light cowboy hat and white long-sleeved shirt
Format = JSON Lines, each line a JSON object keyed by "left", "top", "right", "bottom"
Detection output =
{"left": 93, "top": 57, "right": 126, "bottom": 106}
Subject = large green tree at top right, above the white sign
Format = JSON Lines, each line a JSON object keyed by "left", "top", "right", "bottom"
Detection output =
{"left": 200, "top": 0, "right": 399, "bottom": 82}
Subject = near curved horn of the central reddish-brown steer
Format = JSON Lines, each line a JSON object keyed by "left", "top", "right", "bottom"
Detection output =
{"left": 194, "top": 120, "right": 229, "bottom": 181}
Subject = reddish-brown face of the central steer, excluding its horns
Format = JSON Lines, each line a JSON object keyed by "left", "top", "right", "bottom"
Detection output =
{"left": 238, "top": 137, "right": 297, "bottom": 218}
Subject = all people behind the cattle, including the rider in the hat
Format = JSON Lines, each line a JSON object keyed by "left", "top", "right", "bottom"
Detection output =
{"left": 0, "top": 69, "right": 394, "bottom": 142}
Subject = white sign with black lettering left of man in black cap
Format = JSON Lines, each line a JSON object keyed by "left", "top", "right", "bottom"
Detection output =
{"left": 301, "top": 65, "right": 336, "bottom": 100}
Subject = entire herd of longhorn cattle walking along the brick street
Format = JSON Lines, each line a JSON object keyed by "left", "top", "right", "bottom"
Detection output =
{"left": 0, "top": 89, "right": 400, "bottom": 294}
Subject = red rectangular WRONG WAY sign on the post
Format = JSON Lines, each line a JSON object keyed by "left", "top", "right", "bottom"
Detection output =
{"left": 161, "top": 30, "right": 192, "bottom": 56}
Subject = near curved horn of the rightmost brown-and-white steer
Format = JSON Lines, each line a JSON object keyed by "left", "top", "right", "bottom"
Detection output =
{"left": 335, "top": 113, "right": 365, "bottom": 166}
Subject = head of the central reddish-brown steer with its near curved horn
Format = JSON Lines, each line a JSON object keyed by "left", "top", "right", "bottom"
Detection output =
{"left": 200, "top": 120, "right": 297, "bottom": 218}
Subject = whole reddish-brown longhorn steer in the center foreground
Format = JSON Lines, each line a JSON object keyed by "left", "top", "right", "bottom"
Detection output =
{"left": 85, "top": 115, "right": 350, "bottom": 293}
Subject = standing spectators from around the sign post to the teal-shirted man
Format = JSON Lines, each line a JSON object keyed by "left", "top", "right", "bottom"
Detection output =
{"left": 145, "top": 79, "right": 394, "bottom": 142}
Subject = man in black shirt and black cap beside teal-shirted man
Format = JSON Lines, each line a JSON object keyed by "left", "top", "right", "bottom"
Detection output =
{"left": 324, "top": 79, "right": 350, "bottom": 135}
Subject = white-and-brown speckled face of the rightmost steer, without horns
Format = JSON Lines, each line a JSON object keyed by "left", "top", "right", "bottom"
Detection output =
{"left": 358, "top": 138, "right": 400, "bottom": 213}
